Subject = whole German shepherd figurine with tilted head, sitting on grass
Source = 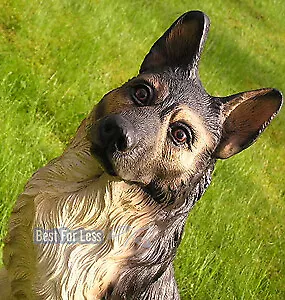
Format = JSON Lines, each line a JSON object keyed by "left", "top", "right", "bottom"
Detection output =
{"left": 1, "top": 11, "right": 282, "bottom": 300}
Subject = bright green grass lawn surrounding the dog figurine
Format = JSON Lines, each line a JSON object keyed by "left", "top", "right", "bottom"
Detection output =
{"left": 0, "top": 0, "right": 285, "bottom": 300}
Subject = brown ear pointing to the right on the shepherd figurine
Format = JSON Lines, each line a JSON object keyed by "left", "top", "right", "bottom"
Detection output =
{"left": 215, "top": 89, "right": 282, "bottom": 158}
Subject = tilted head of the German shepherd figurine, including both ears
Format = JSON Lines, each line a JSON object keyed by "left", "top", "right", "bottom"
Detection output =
{"left": 86, "top": 11, "right": 282, "bottom": 199}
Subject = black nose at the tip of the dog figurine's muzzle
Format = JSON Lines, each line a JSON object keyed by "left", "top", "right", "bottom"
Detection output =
{"left": 98, "top": 115, "right": 136, "bottom": 152}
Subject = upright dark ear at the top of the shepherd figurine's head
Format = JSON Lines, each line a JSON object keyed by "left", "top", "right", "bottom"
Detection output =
{"left": 140, "top": 11, "right": 210, "bottom": 73}
